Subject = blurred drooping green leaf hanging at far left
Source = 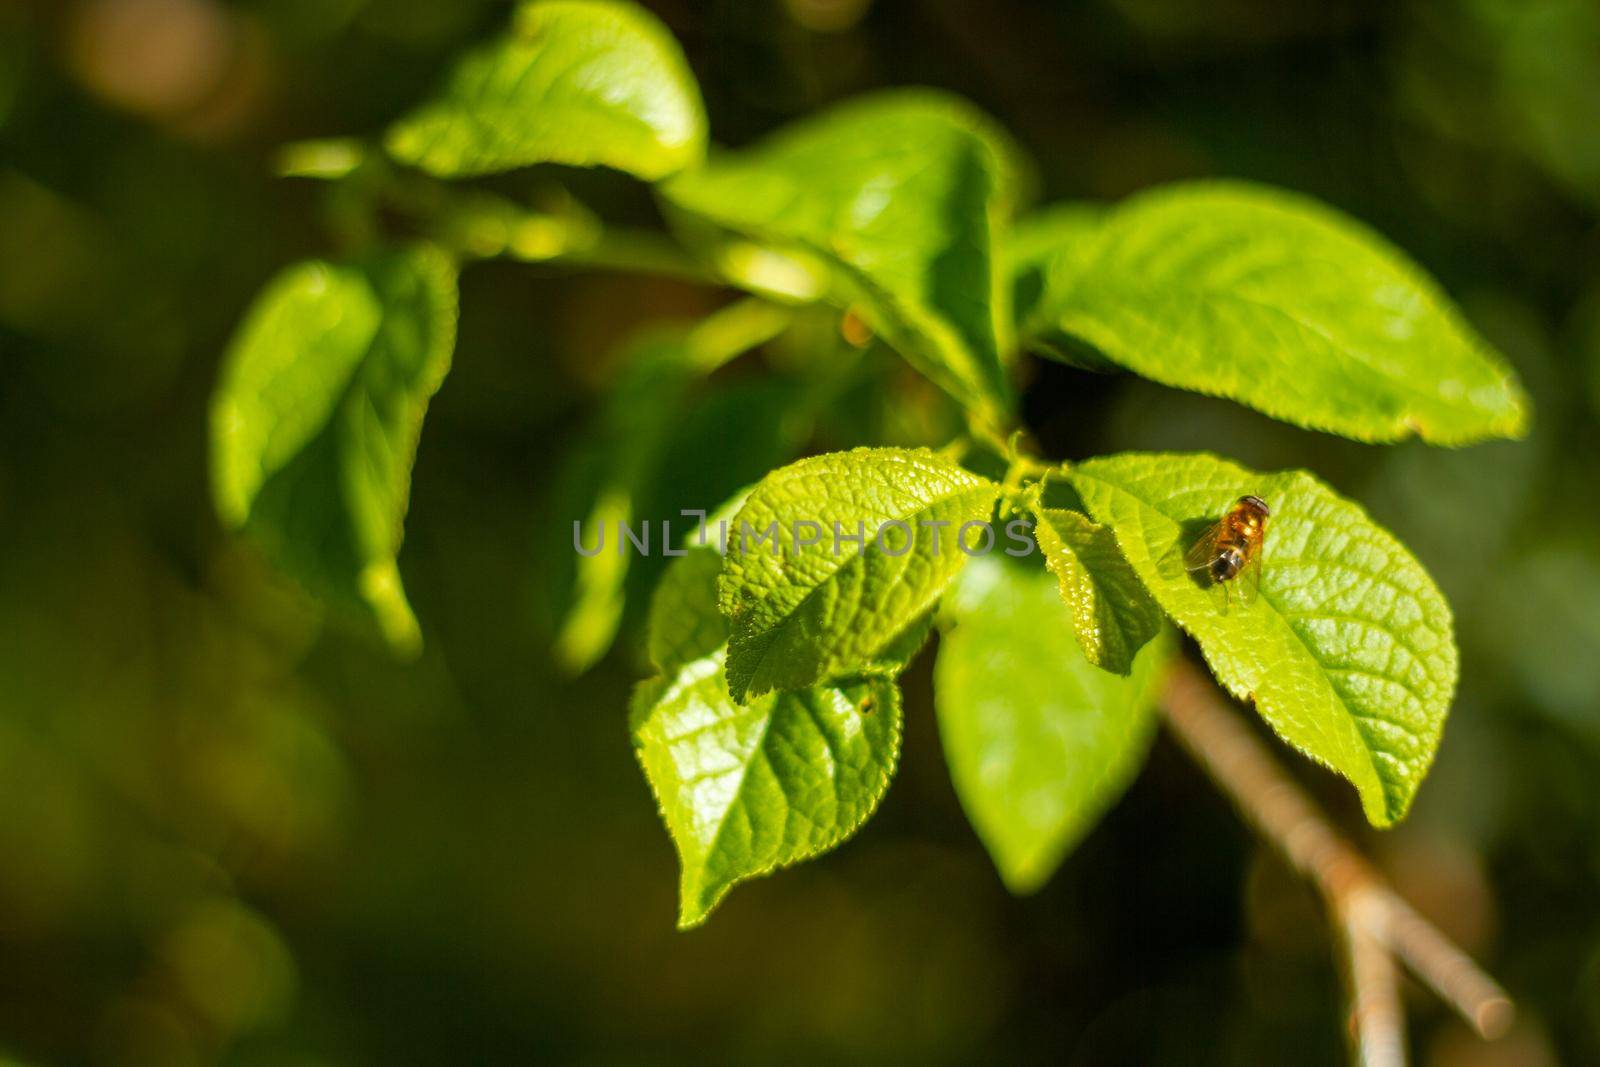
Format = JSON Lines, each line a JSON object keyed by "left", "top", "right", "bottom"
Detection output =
{"left": 211, "top": 246, "right": 456, "bottom": 651}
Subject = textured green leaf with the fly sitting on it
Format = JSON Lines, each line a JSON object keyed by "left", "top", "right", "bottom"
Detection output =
{"left": 1070, "top": 453, "right": 1458, "bottom": 827}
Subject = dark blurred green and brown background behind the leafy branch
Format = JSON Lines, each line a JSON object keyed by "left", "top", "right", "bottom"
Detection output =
{"left": 0, "top": 0, "right": 1600, "bottom": 1067}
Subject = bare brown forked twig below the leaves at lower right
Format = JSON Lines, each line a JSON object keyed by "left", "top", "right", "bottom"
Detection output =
{"left": 1162, "top": 661, "right": 1512, "bottom": 1067}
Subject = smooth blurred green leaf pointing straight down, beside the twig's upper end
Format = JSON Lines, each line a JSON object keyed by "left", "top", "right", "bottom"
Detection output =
{"left": 933, "top": 557, "right": 1171, "bottom": 893}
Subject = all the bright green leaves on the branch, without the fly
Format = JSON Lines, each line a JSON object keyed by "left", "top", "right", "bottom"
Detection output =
{"left": 211, "top": 0, "right": 1530, "bottom": 926}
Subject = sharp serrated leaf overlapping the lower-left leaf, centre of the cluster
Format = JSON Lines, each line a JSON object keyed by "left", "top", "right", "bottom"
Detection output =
{"left": 718, "top": 448, "right": 1000, "bottom": 702}
